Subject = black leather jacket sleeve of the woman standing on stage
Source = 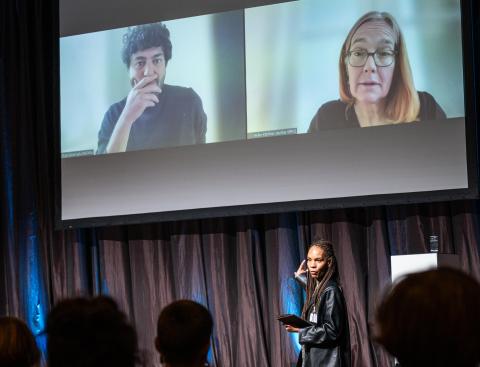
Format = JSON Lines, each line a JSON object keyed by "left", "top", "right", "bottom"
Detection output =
{"left": 299, "top": 287, "right": 345, "bottom": 346}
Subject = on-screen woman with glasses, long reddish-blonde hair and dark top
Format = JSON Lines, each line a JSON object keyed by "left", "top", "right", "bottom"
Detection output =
{"left": 308, "top": 12, "right": 446, "bottom": 132}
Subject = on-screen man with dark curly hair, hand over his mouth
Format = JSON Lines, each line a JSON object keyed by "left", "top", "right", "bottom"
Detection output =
{"left": 97, "top": 23, "right": 207, "bottom": 154}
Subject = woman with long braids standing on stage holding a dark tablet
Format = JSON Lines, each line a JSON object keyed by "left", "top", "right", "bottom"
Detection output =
{"left": 285, "top": 240, "right": 351, "bottom": 367}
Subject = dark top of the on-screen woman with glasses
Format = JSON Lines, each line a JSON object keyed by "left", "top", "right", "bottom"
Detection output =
{"left": 308, "top": 92, "right": 447, "bottom": 133}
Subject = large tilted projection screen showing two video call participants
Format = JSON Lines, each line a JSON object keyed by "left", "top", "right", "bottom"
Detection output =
{"left": 57, "top": 0, "right": 477, "bottom": 227}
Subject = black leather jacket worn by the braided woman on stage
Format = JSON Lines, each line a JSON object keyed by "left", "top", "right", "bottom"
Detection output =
{"left": 296, "top": 277, "right": 351, "bottom": 367}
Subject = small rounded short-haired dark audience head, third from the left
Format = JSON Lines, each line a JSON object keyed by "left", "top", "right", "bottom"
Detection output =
{"left": 155, "top": 300, "right": 213, "bottom": 367}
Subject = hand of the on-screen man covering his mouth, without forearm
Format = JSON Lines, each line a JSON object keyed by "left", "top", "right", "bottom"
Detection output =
{"left": 122, "top": 74, "right": 162, "bottom": 123}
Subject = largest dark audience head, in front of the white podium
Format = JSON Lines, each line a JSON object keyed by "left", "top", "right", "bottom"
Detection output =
{"left": 377, "top": 268, "right": 480, "bottom": 367}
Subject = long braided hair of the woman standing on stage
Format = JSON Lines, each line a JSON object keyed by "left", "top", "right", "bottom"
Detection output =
{"left": 302, "top": 240, "right": 339, "bottom": 319}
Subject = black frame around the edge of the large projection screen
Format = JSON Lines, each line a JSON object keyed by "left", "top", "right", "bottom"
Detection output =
{"left": 53, "top": 0, "right": 480, "bottom": 229}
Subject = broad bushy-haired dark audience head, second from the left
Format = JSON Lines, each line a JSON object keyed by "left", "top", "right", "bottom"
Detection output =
{"left": 46, "top": 296, "right": 138, "bottom": 367}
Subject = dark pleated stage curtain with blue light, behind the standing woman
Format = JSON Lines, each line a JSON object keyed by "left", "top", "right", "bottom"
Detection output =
{"left": 0, "top": 0, "right": 480, "bottom": 367}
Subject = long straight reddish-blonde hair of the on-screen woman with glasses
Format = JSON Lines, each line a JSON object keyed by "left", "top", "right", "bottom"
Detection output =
{"left": 339, "top": 11, "right": 420, "bottom": 123}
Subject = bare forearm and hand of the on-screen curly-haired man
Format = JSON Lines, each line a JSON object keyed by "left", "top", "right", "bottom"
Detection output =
{"left": 106, "top": 74, "right": 162, "bottom": 153}
